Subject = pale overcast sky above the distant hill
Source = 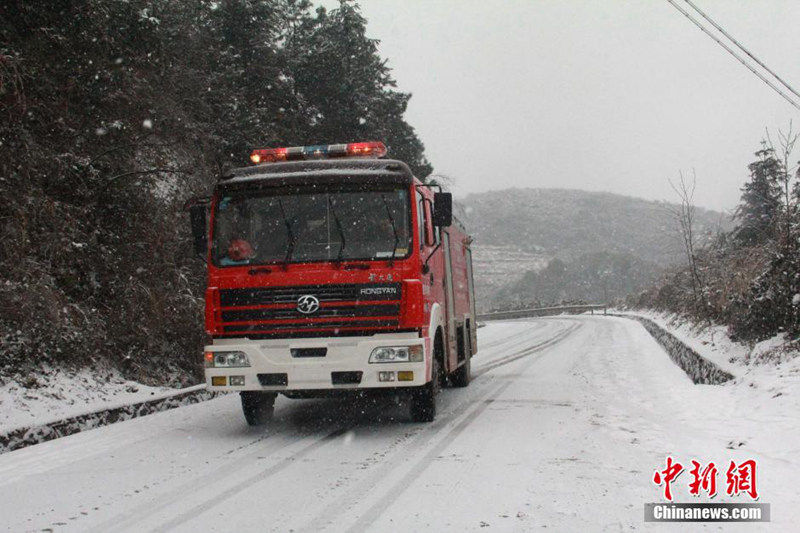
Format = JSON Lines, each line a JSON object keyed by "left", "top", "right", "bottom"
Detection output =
{"left": 322, "top": 0, "right": 800, "bottom": 209}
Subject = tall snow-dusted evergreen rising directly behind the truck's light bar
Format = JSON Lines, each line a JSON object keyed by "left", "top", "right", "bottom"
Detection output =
{"left": 287, "top": 0, "right": 432, "bottom": 178}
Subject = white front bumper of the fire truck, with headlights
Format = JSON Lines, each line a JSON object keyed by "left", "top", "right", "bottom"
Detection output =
{"left": 205, "top": 333, "right": 430, "bottom": 392}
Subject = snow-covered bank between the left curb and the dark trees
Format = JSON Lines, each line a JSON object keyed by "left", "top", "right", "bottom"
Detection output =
{"left": 0, "top": 369, "right": 181, "bottom": 433}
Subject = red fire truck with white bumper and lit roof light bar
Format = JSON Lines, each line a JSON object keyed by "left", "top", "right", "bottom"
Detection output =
{"left": 189, "top": 142, "right": 477, "bottom": 425}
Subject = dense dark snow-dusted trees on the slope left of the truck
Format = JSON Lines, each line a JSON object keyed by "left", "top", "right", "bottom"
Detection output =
{"left": 0, "top": 0, "right": 431, "bottom": 382}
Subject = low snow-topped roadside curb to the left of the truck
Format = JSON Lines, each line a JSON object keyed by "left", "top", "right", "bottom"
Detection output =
{"left": 0, "top": 385, "right": 219, "bottom": 454}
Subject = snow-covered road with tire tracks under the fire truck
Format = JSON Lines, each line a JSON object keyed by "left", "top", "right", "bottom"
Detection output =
{"left": 0, "top": 316, "right": 800, "bottom": 532}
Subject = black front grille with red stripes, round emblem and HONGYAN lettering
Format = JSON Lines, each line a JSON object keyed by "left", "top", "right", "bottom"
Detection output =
{"left": 218, "top": 283, "right": 402, "bottom": 338}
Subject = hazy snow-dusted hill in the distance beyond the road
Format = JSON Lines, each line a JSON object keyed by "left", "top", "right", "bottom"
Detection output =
{"left": 458, "top": 188, "right": 730, "bottom": 311}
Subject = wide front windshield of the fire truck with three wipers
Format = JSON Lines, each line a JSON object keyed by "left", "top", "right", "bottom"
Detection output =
{"left": 213, "top": 186, "right": 411, "bottom": 266}
